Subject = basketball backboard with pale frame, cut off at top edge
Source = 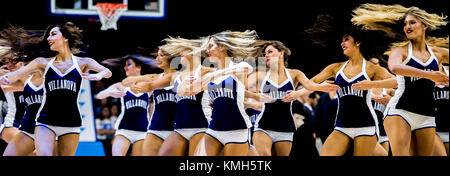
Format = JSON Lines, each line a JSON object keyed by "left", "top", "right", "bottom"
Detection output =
{"left": 49, "top": 0, "right": 166, "bottom": 19}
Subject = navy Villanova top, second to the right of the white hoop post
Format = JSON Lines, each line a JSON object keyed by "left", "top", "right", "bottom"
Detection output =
{"left": 148, "top": 74, "right": 177, "bottom": 131}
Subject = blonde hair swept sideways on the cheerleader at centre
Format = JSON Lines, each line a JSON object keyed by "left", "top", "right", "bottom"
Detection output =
{"left": 202, "top": 30, "right": 258, "bottom": 59}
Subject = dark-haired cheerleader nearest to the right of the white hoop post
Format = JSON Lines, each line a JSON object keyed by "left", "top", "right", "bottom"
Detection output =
{"left": 96, "top": 56, "right": 151, "bottom": 156}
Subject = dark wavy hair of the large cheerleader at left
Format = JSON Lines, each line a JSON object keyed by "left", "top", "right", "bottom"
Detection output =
{"left": 42, "top": 22, "right": 83, "bottom": 54}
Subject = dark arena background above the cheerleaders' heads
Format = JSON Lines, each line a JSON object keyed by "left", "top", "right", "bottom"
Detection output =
{"left": 0, "top": 0, "right": 448, "bottom": 157}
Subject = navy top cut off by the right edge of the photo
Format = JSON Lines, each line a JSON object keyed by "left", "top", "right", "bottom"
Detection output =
{"left": 434, "top": 86, "right": 450, "bottom": 132}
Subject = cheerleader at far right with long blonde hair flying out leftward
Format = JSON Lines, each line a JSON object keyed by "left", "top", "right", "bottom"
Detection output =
{"left": 352, "top": 4, "right": 448, "bottom": 156}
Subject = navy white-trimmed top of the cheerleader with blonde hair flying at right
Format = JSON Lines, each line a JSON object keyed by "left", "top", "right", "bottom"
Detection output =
{"left": 388, "top": 43, "right": 439, "bottom": 116}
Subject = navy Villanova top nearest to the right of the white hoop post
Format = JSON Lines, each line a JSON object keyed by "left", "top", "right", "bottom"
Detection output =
{"left": 114, "top": 87, "right": 150, "bottom": 132}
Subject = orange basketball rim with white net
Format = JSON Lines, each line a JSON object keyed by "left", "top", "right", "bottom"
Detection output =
{"left": 95, "top": 3, "right": 128, "bottom": 31}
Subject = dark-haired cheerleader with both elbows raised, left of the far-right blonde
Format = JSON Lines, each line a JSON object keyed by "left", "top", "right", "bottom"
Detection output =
{"left": 311, "top": 28, "right": 393, "bottom": 156}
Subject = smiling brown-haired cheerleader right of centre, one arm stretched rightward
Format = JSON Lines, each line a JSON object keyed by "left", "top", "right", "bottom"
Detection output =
{"left": 249, "top": 41, "right": 339, "bottom": 156}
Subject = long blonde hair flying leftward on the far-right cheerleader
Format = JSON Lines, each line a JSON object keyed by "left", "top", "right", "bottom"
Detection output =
{"left": 351, "top": 4, "right": 447, "bottom": 39}
